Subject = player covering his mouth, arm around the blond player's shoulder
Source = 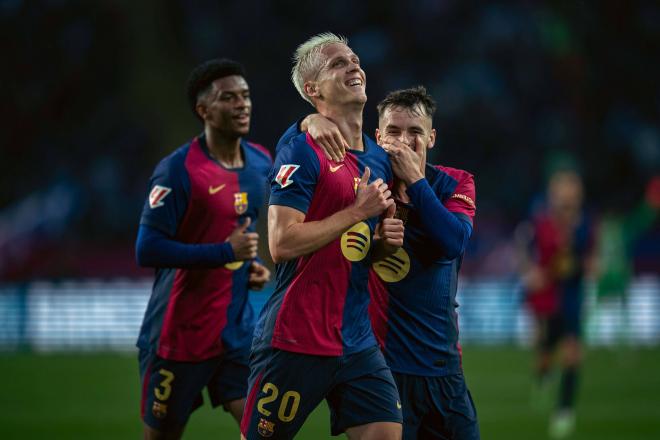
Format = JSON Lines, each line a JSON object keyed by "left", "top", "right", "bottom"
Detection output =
{"left": 301, "top": 87, "right": 480, "bottom": 440}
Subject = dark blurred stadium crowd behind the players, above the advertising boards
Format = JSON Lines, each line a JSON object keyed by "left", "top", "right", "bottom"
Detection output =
{"left": 0, "top": 0, "right": 660, "bottom": 281}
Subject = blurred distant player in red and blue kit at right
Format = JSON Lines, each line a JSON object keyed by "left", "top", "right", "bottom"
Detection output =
{"left": 516, "top": 170, "right": 593, "bottom": 438}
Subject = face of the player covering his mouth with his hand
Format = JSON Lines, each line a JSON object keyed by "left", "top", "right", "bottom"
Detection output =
{"left": 376, "top": 107, "right": 435, "bottom": 167}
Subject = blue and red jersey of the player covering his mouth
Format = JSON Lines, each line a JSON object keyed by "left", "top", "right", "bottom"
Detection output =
{"left": 369, "top": 165, "right": 475, "bottom": 376}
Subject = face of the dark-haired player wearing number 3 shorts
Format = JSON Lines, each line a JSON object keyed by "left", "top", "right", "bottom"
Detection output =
{"left": 202, "top": 75, "right": 252, "bottom": 137}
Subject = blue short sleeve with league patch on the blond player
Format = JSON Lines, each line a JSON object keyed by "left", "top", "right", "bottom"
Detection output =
{"left": 269, "top": 134, "right": 321, "bottom": 214}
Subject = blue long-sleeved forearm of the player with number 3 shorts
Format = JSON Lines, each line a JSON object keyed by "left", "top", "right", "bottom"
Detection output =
{"left": 135, "top": 225, "right": 234, "bottom": 269}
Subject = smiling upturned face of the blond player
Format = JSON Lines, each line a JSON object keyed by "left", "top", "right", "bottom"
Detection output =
{"left": 315, "top": 44, "right": 367, "bottom": 104}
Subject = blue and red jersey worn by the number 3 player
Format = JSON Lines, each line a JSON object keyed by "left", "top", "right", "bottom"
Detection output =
{"left": 137, "top": 135, "right": 272, "bottom": 361}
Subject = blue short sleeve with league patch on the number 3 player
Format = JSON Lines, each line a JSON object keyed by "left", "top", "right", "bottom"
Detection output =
{"left": 140, "top": 153, "right": 190, "bottom": 237}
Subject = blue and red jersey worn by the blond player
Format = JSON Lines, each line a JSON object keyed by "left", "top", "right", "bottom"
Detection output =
{"left": 253, "top": 133, "right": 392, "bottom": 356}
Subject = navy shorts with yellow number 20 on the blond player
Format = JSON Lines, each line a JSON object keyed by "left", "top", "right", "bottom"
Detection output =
{"left": 241, "top": 346, "right": 402, "bottom": 440}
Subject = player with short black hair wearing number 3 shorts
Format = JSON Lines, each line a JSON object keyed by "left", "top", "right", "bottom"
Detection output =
{"left": 136, "top": 59, "right": 272, "bottom": 439}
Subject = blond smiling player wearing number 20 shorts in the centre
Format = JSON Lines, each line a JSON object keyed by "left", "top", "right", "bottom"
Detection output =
{"left": 241, "top": 33, "right": 403, "bottom": 440}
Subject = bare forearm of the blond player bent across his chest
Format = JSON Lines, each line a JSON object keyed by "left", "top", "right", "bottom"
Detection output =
{"left": 268, "top": 206, "right": 364, "bottom": 263}
